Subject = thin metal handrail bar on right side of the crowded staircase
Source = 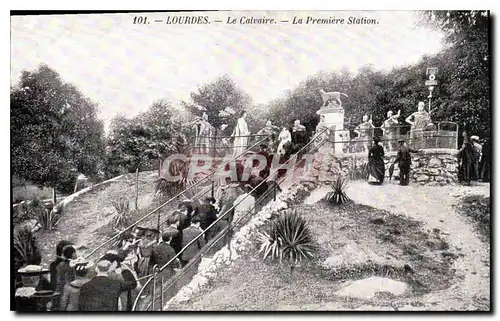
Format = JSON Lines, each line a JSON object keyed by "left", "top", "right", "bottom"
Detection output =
{"left": 132, "top": 129, "right": 327, "bottom": 311}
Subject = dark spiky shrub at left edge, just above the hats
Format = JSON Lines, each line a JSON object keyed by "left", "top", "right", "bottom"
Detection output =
{"left": 14, "top": 227, "right": 42, "bottom": 271}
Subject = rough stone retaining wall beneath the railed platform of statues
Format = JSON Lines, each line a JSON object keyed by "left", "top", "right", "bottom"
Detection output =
{"left": 309, "top": 149, "right": 458, "bottom": 185}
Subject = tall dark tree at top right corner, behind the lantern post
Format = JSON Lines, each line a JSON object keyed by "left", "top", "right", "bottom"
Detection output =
{"left": 422, "top": 11, "right": 492, "bottom": 136}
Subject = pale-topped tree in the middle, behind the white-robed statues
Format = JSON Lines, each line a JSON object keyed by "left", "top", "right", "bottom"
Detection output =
{"left": 183, "top": 75, "right": 251, "bottom": 129}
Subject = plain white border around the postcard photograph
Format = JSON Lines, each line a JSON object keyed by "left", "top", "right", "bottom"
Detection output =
{"left": 0, "top": 0, "right": 500, "bottom": 320}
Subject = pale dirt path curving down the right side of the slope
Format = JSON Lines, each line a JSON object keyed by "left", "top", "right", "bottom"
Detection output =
{"left": 342, "top": 182, "right": 490, "bottom": 310}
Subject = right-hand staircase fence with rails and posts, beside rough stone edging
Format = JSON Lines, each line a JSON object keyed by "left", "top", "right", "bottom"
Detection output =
{"left": 133, "top": 130, "right": 326, "bottom": 311}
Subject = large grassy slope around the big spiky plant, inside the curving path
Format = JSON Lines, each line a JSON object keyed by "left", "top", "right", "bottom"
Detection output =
{"left": 172, "top": 201, "right": 460, "bottom": 310}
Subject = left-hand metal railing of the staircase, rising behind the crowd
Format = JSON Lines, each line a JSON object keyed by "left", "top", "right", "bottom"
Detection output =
{"left": 85, "top": 132, "right": 269, "bottom": 259}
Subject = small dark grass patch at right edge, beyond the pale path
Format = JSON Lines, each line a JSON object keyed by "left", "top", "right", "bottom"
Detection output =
{"left": 458, "top": 195, "right": 491, "bottom": 243}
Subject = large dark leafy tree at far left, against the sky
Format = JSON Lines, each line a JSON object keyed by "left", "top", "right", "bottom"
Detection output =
{"left": 10, "top": 65, "right": 104, "bottom": 192}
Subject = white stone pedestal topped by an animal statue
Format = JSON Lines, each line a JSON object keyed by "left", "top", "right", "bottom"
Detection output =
{"left": 316, "top": 90, "right": 350, "bottom": 153}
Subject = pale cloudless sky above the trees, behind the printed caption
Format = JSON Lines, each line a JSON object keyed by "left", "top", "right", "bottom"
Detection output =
{"left": 11, "top": 11, "right": 443, "bottom": 124}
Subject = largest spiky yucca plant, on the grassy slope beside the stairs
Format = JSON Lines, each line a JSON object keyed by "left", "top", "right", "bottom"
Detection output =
{"left": 259, "top": 211, "right": 317, "bottom": 274}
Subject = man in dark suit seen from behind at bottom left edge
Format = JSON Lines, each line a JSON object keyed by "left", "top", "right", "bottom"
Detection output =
{"left": 78, "top": 260, "right": 126, "bottom": 311}
